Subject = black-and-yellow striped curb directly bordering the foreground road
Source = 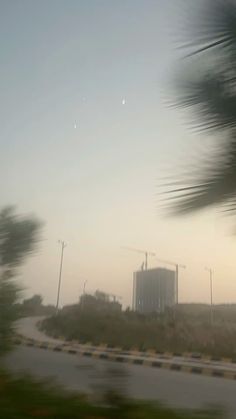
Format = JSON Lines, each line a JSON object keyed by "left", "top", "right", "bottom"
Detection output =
{"left": 13, "top": 336, "right": 236, "bottom": 380}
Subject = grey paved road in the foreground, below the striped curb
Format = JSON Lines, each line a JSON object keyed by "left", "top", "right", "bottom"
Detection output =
{"left": 5, "top": 320, "right": 236, "bottom": 419}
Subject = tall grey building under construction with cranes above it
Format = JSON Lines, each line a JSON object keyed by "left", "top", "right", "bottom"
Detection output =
{"left": 133, "top": 268, "right": 175, "bottom": 313}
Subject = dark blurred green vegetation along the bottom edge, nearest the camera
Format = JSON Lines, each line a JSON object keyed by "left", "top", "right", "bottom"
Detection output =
{"left": 0, "top": 372, "right": 223, "bottom": 419}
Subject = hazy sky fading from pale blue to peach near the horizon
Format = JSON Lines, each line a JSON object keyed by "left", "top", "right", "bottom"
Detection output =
{"left": 0, "top": 0, "right": 236, "bottom": 306}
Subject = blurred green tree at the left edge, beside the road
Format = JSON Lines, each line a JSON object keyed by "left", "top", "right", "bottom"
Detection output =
{"left": 0, "top": 207, "right": 41, "bottom": 354}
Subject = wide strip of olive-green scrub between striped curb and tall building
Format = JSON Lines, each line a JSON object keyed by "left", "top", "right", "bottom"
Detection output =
{"left": 42, "top": 301, "right": 236, "bottom": 360}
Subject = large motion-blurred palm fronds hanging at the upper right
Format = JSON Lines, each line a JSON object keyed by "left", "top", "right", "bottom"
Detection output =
{"left": 168, "top": 0, "right": 236, "bottom": 220}
